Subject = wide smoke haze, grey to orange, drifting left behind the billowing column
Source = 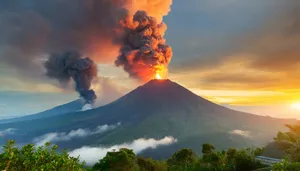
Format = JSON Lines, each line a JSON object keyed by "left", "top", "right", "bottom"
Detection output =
{"left": 0, "top": 0, "right": 172, "bottom": 83}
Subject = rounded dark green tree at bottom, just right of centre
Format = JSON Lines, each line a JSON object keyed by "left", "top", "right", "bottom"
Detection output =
{"left": 167, "top": 148, "right": 197, "bottom": 171}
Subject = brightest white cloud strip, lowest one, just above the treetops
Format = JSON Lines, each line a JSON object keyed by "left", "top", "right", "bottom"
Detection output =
{"left": 69, "top": 137, "right": 177, "bottom": 165}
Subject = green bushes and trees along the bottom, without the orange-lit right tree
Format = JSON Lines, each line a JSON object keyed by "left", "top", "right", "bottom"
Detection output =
{"left": 0, "top": 141, "right": 264, "bottom": 171}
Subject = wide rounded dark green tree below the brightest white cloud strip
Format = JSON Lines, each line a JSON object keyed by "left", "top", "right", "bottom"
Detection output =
{"left": 93, "top": 148, "right": 137, "bottom": 171}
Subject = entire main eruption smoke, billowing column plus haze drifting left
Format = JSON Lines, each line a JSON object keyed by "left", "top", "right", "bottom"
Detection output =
{"left": 0, "top": 0, "right": 172, "bottom": 85}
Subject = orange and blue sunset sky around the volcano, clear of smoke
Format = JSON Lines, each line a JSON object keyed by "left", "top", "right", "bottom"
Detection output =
{"left": 0, "top": 0, "right": 300, "bottom": 119}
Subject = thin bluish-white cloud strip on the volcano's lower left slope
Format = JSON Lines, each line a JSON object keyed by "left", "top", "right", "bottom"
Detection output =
{"left": 33, "top": 123, "right": 121, "bottom": 146}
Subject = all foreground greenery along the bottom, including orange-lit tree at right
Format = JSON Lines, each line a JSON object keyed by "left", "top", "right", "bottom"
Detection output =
{"left": 0, "top": 125, "right": 300, "bottom": 171}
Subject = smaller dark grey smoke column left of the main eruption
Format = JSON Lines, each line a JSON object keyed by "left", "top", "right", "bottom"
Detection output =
{"left": 45, "top": 52, "right": 97, "bottom": 104}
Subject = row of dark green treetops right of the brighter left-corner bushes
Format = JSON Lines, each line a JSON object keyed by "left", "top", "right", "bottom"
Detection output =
{"left": 89, "top": 144, "right": 265, "bottom": 171}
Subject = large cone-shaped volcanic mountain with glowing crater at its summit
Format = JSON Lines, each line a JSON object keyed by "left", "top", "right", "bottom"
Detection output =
{"left": 0, "top": 80, "right": 295, "bottom": 158}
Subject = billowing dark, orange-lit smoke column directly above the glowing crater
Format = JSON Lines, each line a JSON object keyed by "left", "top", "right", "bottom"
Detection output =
{"left": 115, "top": 11, "right": 172, "bottom": 81}
